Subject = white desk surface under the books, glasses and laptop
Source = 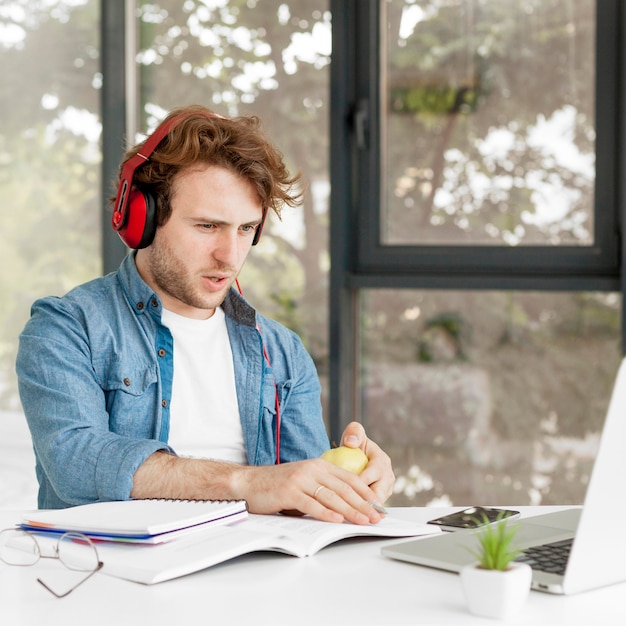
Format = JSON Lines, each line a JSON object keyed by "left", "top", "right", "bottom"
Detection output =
{"left": 0, "top": 507, "right": 626, "bottom": 626}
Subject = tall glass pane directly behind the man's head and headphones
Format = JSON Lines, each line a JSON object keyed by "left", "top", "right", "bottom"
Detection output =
{"left": 137, "top": 0, "right": 331, "bottom": 414}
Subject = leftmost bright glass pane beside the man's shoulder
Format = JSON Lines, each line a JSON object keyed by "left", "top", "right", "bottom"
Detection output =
{"left": 0, "top": 0, "right": 102, "bottom": 509}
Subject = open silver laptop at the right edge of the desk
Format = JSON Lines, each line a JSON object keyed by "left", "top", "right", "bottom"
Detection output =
{"left": 381, "top": 359, "right": 626, "bottom": 594}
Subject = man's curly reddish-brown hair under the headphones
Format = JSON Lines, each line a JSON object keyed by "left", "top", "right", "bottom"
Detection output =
{"left": 111, "top": 105, "right": 302, "bottom": 226}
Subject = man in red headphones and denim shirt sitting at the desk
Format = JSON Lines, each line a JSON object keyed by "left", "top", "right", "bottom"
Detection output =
{"left": 17, "top": 106, "right": 394, "bottom": 524}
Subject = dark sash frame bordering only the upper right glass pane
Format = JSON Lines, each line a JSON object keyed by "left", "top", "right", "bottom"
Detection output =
{"left": 353, "top": 0, "right": 620, "bottom": 289}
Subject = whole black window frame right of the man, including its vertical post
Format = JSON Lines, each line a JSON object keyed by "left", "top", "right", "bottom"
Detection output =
{"left": 329, "top": 0, "right": 626, "bottom": 437}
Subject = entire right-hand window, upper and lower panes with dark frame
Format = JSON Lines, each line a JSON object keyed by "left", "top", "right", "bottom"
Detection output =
{"left": 330, "top": 0, "right": 623, "bottom": 505}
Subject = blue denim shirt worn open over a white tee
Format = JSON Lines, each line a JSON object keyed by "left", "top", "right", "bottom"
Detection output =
{"left": 16, "top": 254, "right": 329, "bottom": 508}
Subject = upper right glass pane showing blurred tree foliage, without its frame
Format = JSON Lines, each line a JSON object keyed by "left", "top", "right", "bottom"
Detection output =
{"left": 381, "top": 0, "right": 595, "bottom": 246}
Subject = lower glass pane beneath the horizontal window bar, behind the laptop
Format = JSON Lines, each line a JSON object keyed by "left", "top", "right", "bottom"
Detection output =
{"left": 360, "top": 289, "right": 621, "bottom": 506}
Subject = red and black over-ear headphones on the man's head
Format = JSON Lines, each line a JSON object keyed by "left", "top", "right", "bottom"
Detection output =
{"left": 111, "top": 114, "right": 267, "bottom": 250}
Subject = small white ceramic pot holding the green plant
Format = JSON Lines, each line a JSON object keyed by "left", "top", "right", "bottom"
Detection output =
{"left": 461, "top": 563, "right": 532, "bottom": 619}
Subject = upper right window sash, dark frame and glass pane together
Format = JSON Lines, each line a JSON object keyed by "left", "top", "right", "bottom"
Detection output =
{"left": 353, "top": 0, "right": 619, "bottom": 280}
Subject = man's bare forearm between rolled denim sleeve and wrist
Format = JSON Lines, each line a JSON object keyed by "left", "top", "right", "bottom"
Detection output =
{"left": 130, "top": 450, "right": 240, "bottom": 500}
